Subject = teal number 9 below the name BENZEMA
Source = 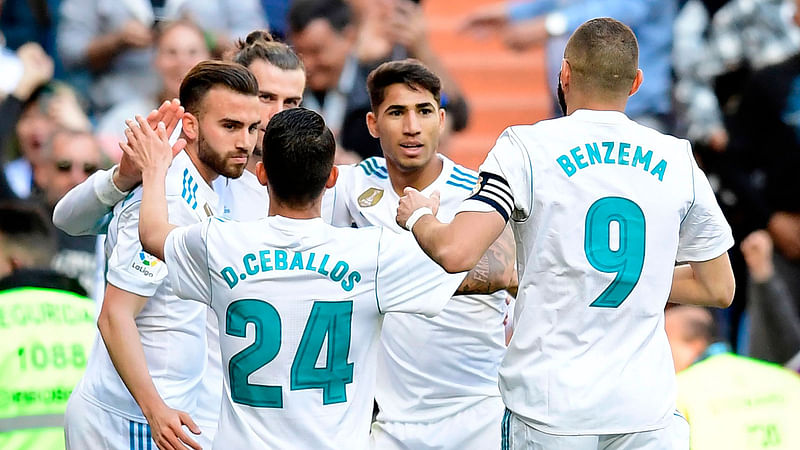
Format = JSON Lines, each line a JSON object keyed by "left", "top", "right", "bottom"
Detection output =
{"left": 583, "top": 197, "right": 645, "bottom": 308}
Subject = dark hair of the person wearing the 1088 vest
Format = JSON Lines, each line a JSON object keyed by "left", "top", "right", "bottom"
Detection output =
{"left": 0, "top": 200, "right": 57, "bottom": 268}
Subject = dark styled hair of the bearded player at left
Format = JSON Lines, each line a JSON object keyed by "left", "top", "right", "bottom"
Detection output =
{"left": 179, "top": 61, "right": 258, "bottom": 115}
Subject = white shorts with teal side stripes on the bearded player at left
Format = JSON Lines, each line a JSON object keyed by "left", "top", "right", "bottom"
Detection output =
{"left": 64, "top": 389, "right": 158, "bottom": 450}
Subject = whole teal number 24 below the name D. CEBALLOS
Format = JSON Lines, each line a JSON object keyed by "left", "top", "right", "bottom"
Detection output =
{"left": 225, "top": 299, "right": 353, "bottom": 408}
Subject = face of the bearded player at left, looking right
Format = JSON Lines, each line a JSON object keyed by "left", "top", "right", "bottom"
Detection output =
{"left": 183, "top": 86, "right": 261, "bottom": 181}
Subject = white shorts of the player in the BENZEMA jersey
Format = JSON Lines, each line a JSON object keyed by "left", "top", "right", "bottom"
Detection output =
{"left": 501, "top": 410, "right": 689, "bottom": 450}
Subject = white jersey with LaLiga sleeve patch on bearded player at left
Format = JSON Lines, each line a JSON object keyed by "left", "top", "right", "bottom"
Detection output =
{"left": 80, "top": 152, "right": 218, "bottom": 422}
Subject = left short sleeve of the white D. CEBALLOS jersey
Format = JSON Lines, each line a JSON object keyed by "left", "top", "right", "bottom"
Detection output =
{"left": 164, "top": 218, "right": 212, "bottom": 304}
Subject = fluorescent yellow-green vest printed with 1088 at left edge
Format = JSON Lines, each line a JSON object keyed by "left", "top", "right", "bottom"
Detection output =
{"left": 0, "top": 287, "right": 97, "bottom": 450}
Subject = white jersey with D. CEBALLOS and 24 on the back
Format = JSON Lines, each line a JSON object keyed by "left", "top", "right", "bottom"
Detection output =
{"left": 164, "top": 216, "right": 465, "bottom": 449}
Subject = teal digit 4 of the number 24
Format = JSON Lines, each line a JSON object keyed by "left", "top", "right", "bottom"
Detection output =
{"left": 291, "top": 301, "right": 353, "bottom": 405}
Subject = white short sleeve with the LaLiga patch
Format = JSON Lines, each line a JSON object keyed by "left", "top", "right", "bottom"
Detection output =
{"left": 106, "top": 202, "right": 167, "bottom": 297}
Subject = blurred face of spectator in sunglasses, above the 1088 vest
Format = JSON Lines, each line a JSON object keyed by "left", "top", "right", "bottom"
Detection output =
{"left": 35, "top": 132, "right": 101, "bottom": 207}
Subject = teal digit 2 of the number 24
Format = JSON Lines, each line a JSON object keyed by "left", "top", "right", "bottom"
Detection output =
{"left": 225, "top": 300, "right": 283, "bottom": 408}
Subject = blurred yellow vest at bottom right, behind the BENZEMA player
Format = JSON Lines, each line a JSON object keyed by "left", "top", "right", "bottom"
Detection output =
{"left": 677, "top": 353, "right": 800, "bottom": 450}
